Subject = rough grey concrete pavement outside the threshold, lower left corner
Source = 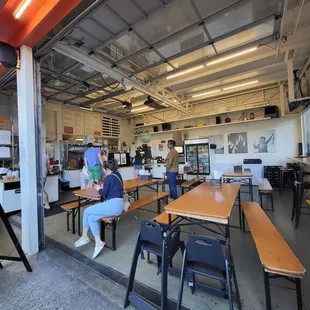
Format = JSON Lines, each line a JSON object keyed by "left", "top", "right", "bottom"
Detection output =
{"left": 0, "top": 225, "right": 133, "bottom": 310}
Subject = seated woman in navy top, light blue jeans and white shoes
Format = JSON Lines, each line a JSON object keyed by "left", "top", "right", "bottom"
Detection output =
{"left": 74, "top": 160, "right": 123, "bottom": 259}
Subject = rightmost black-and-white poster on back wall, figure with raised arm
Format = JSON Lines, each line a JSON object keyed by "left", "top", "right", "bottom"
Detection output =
{"left": 253, "top": 129, "right": 276, "bottom": 153}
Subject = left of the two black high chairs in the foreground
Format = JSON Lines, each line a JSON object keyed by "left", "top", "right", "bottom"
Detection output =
{"left": 124, "top": 221, "right": 185, "bottom": 310}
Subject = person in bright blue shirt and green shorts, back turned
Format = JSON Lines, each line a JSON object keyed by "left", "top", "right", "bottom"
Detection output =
{"left": 84, "top": 143, "right": 103, "bottom": 183}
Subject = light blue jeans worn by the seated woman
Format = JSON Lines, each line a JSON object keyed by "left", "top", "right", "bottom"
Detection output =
{"left": 83, "top": 198, "right": 124, "bottom": 237}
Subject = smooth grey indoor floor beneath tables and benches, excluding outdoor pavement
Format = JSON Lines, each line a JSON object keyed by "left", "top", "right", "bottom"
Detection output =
{"left": 41, "top": 185, "right": 310, "bottom": 310}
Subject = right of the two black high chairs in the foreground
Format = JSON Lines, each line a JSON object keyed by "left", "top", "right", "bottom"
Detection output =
{"left": 177, "top": 236, "right": 241, "bottom": 310}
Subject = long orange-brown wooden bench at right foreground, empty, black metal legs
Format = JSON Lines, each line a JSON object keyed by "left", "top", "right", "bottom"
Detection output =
{"left": 241, "top": 201, "right": 306, "bottom": 310}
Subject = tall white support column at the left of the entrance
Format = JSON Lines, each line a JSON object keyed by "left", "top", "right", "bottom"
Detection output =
{"left": 17, "top": 46, "right": 39, "bottom": 255}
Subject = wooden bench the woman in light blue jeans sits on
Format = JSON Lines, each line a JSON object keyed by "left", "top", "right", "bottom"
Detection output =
{"left": 100, "top": 192, "right": 169, "bottom": 251}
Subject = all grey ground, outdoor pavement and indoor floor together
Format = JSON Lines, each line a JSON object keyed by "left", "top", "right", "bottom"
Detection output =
{"left": 0, "top": 189, "right": 310, "bottom": 310}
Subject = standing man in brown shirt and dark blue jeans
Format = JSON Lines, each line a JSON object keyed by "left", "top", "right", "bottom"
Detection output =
{"left": 166, "top": 140, "right": 179, "bottom": 200}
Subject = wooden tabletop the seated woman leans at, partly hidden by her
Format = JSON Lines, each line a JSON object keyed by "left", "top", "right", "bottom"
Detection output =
{"left": 73, "top": 179, "right": 160, "bottom": 200}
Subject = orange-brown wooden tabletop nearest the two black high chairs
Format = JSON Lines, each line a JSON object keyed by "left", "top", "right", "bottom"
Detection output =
{"left": 165, "top": 182, "right": 240, "bottom": 224}
